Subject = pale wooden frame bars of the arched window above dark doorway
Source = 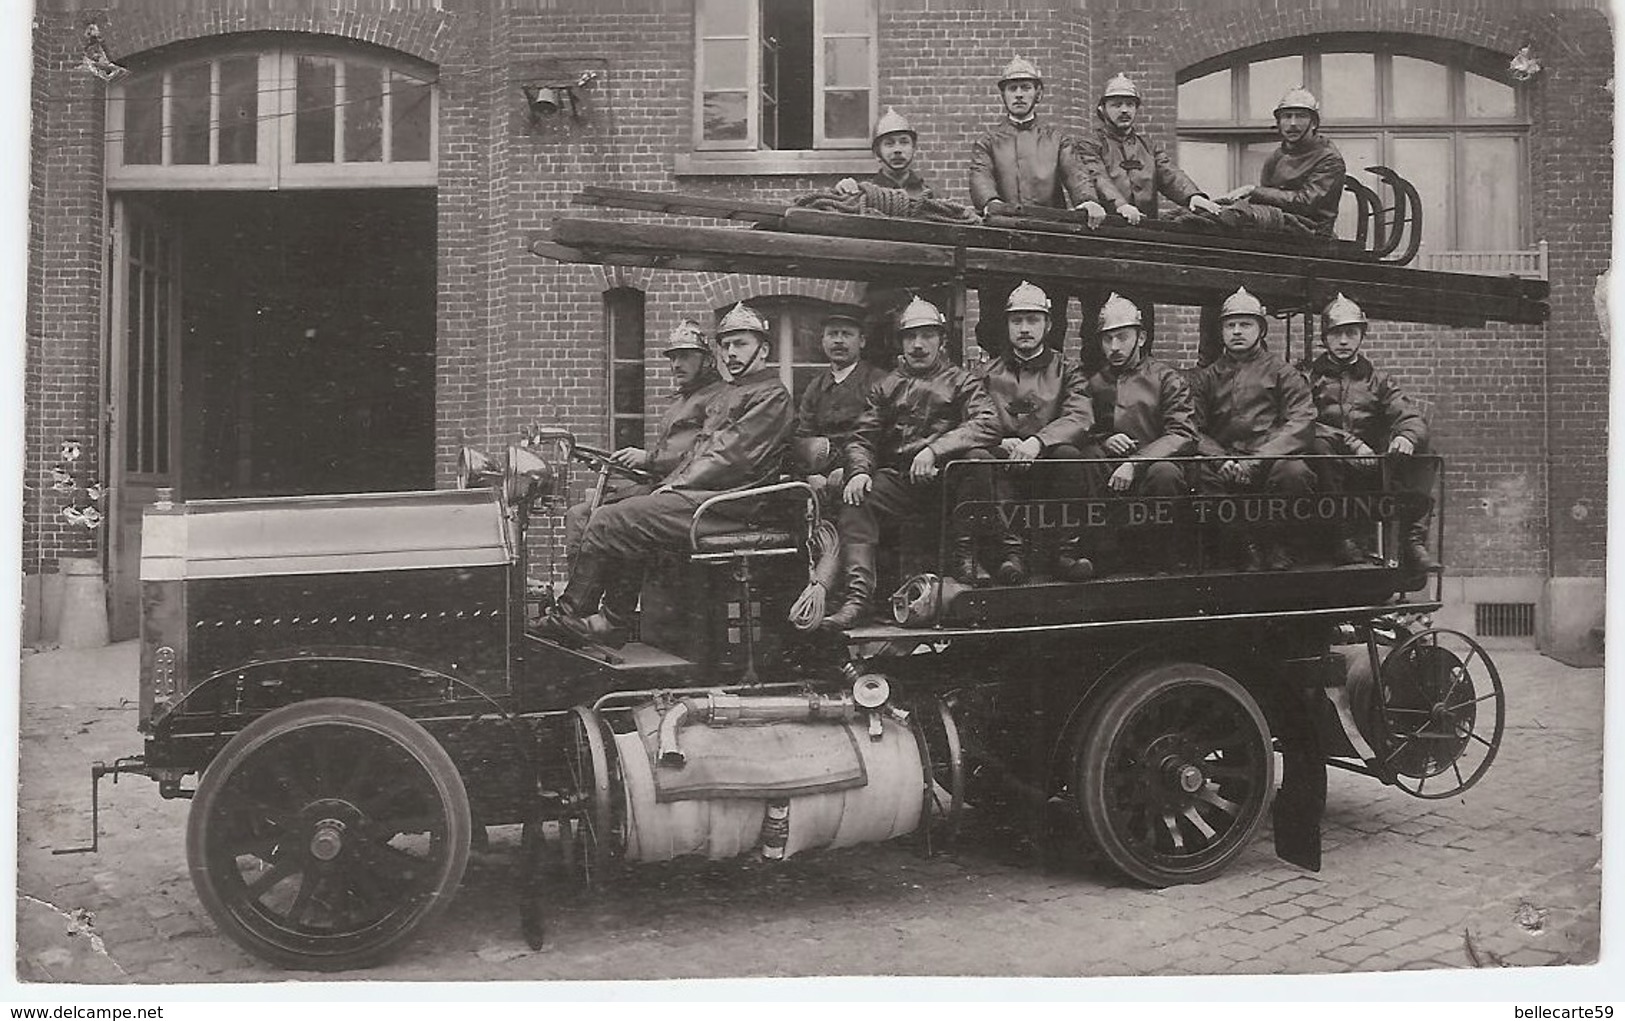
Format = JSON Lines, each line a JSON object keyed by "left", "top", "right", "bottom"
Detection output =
{"left": 104, "top": 41, "right": 440, "bottom": 190}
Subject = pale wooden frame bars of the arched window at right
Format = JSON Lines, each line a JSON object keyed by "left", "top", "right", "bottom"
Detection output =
{"left": 1175, "top": 42, "right": 1532, "bottom": 255}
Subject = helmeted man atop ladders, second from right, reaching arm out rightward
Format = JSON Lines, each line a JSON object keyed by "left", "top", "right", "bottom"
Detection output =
{"left": 1077, "top": 75, "right": 1219, "bottom": 224}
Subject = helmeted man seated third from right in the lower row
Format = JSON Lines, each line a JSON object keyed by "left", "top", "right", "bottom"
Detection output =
{"left": 1084, "top": 294, "right": 1196, "bottom": 569}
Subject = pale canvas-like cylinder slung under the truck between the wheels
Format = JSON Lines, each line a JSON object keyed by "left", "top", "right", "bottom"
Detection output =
{"left": 614, "top": 719, "right": 925, "bottom": 862}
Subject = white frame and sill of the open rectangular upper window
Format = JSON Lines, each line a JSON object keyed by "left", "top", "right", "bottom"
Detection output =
{"left": 692, "top": 0, "right": 881, "bottom": 163}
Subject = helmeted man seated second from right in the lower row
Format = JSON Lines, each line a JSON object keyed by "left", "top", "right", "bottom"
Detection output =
{"left": 1191, "top": 288, "right": 1315, "bottom": 571}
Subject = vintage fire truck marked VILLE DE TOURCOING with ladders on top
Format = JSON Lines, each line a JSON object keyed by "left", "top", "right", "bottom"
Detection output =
{"left": 66, "top": 177, "right": 1545, "bottom": 969}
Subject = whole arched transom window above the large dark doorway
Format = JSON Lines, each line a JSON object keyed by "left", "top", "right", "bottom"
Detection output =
{"left": 107, "top": 37, "right": 437, "bottom": 189}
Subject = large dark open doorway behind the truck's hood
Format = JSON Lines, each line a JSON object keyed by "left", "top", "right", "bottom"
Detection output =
{"left": 107, "top": 189, "right": 436, "bottom": 637}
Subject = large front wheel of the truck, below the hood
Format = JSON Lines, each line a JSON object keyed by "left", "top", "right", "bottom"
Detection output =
{"left": 187, "top": 699, "right": 471, "bottom": 971}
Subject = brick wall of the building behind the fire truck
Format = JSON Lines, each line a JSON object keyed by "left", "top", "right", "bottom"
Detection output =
{"left": 24, "top": 0, "right": 1612, "bottom": 591}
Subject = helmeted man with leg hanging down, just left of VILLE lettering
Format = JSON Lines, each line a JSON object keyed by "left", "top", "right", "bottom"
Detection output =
{"left": 824, "top": 298, "right": 999, "bottom": 631}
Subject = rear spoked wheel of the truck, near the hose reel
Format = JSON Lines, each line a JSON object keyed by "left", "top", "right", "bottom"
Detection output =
{"left": 1074, "top": 663, "right": 1276, "bottom": 886}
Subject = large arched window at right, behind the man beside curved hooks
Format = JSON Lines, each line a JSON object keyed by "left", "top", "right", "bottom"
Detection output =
{"left": 1178, "top": 36, "right": 1529, "bottom": 268}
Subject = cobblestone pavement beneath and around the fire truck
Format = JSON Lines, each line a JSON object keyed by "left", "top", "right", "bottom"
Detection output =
{"left": 16, "top": 644, "right": 1604, "bottom": 984}
